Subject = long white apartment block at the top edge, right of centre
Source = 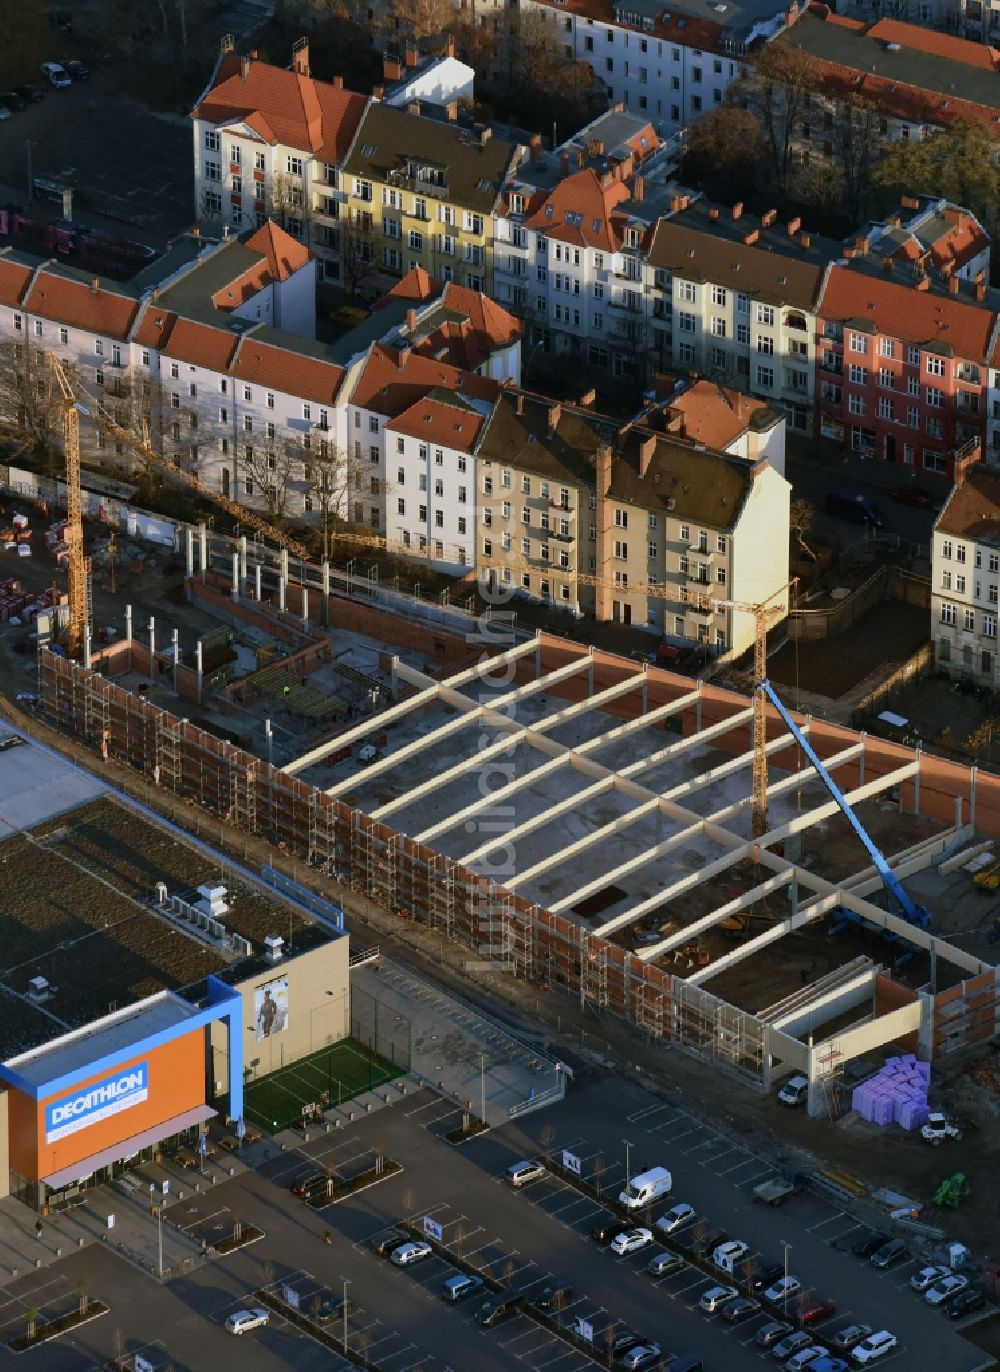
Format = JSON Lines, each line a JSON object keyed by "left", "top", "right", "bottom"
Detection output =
{"left": 521, "top": 0, "right": 796, "bottom": 137}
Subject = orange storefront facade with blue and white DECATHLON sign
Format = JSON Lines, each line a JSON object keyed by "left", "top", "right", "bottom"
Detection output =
{"left": 8, "top": 1028, "right": 206, "bottom": 1181}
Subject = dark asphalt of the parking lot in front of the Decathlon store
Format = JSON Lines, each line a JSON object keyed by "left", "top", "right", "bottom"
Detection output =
{"left": 7, "top": 1077, "right": 982, "bottom": 1372}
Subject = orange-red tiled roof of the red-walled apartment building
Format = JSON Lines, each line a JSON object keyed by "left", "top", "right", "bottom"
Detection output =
{"left": 818, "top": 266, "right": 995, "bottom": 362}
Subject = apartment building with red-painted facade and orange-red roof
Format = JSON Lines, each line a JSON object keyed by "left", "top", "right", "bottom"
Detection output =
{"left": 818, "top": 257, "right": 997, "bottom": 475}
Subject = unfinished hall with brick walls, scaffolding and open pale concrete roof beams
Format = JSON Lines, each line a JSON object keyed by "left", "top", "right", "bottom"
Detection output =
{"left": 41, "top": 635, "right": 1000, "bottom": 1113}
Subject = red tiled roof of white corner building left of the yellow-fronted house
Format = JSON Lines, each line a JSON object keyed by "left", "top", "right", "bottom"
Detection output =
{"left": 192, "top": 54, "right": 368, "bottom": 162}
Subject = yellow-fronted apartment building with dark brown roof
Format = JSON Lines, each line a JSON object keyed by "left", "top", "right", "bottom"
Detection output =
{"left": 340, "top": 102, "right": 524, "bottom": 295}
